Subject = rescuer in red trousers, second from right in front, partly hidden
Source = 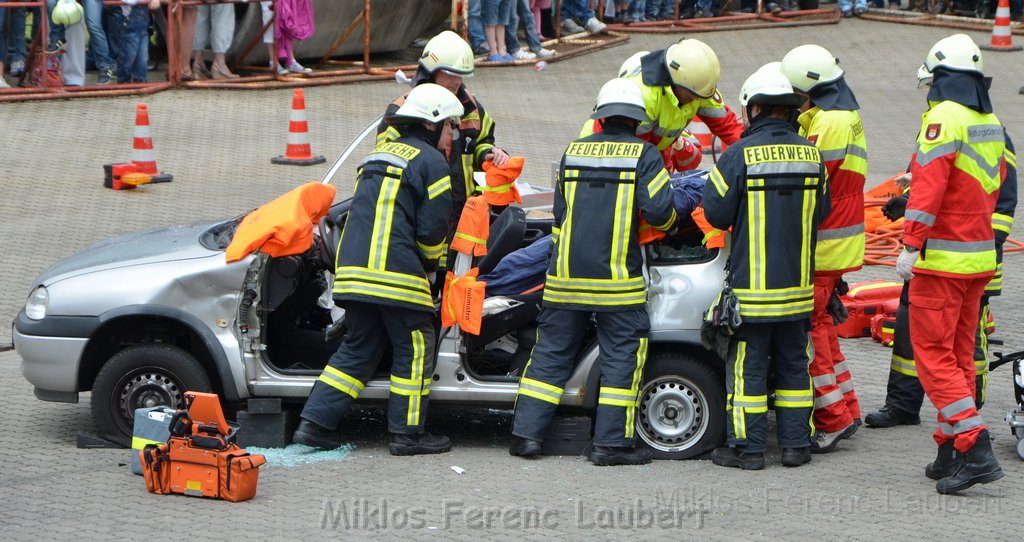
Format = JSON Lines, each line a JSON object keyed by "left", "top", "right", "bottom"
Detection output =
{"left": 780, "top": 44, "right": 867, "bottom": 453}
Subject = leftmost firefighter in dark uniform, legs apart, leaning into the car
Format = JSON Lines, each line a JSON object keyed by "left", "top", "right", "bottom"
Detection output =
{"left": 293, "top": 84, "right": 463, "bottom": 455}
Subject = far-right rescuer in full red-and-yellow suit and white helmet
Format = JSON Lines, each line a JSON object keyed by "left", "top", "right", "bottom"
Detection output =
{"left": 896, "top": 34, "right": 1006, "bottom": 494}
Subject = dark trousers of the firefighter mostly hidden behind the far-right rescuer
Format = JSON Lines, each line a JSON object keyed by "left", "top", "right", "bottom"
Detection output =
{"left": 886, "top": 283, "right": 989, "bottom": 414}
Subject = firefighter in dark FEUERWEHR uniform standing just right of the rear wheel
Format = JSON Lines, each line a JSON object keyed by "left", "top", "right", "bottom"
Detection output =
{"left": 703, "top": 65, "right": 829, "bottom": 470}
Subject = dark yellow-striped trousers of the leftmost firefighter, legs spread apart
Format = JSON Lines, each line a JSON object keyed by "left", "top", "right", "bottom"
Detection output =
{"left": 302, "top": 301, "right": 435, "bottom": 434}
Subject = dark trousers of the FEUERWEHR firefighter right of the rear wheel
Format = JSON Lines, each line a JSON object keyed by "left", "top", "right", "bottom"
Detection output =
{"left": 725, "top": 319, "right": 814, "bottom": 453}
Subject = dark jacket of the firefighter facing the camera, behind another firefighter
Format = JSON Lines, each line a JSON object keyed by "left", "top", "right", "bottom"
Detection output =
{"left": 377, "top": 84, "right": 495, "bottom": 230}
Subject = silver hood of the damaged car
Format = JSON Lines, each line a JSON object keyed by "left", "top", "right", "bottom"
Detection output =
{"left": 37, "top": 222, "right": 223, "bottom": 284}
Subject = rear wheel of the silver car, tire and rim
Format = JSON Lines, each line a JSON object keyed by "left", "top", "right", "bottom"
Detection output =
{"left": 636, "top": 351, "right": 725, "bottom": 459}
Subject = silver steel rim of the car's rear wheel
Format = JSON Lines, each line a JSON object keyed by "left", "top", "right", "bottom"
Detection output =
{"left": 637, "top": 376, "right": 709, "bottom": 453}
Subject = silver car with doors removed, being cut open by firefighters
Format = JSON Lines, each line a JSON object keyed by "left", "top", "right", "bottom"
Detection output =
{"left": 13, "top": 122, "right": 727, "bottom": 459}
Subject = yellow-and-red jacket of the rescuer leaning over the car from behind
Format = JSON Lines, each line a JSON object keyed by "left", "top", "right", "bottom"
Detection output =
{"left": 626, "top": 49, "right": 743, "bottom": 151}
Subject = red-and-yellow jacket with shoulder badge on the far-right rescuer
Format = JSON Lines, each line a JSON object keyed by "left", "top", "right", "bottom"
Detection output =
{"left": 903, "top": 100, "right": 1006, "bottom": 278}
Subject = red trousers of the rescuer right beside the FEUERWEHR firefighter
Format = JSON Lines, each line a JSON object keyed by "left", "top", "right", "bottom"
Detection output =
{"left": 810, "top": 275, "right": 860, "bottom": 432}
